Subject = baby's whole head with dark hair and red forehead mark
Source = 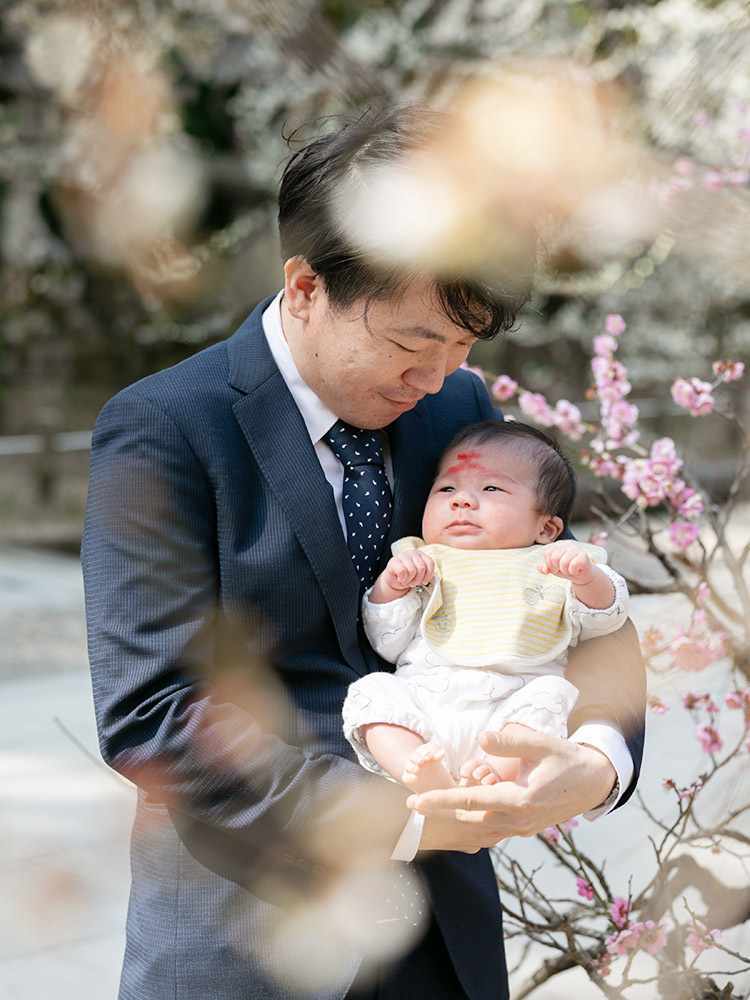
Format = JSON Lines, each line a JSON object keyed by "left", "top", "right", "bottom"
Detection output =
{"left": 422, "top": 420, "right": 576, "bottom": 549}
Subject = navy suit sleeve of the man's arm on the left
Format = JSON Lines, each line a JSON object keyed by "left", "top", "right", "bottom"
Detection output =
{"left": 82, "top": 392, "right": 405, "bottom": 883}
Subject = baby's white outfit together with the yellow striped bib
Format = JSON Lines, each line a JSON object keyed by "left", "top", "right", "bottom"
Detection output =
{"left": 343, "top": 538, "right": 628, "bottom": 777}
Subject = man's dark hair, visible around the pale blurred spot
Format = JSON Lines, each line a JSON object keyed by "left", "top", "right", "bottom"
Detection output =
{"left": 279, "top": 105, "right": 523, "bottom": 340}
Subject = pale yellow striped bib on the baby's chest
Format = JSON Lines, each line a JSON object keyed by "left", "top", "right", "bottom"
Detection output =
{"left": 393, "top": 538, "right": 606, "bottom": 669}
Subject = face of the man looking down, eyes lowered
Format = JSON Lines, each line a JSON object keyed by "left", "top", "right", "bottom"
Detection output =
{"left": 285, "top": 279, "right": 476, "bottom": 428}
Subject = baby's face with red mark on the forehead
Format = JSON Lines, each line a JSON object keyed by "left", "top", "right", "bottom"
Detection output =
{"left": 422, "top": 442, "right": 562, "bottom": 549}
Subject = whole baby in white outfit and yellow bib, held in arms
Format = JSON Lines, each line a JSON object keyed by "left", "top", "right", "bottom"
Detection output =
{"left": 343, "top": 421, "right": 628, "bottom": 792}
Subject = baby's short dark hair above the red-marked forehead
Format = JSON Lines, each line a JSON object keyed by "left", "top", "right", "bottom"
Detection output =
{"left": 441, "top": 420, "right": 576, "bottom": 527}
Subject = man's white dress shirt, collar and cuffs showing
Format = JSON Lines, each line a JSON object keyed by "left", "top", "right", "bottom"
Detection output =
{"left": 263, "top": 292, "right": 633, "bottom": 861}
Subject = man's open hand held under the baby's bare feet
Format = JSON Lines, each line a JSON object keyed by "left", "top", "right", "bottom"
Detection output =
{"left": 407, "top": 723, "right": 617, "bottom": 853}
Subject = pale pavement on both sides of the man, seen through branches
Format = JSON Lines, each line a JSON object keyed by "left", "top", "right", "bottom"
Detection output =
{"left": 0, "top": 547, "right": 750, "bottom": 1000}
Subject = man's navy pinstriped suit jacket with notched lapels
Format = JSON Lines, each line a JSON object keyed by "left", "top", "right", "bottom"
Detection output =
{"left": 83, "top": 302, "right": 642, "bottom": 1000}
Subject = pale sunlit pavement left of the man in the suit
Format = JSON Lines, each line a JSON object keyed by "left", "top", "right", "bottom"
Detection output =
{"left": 0, "top": 549, "right": 134, "bottom": 1000}
